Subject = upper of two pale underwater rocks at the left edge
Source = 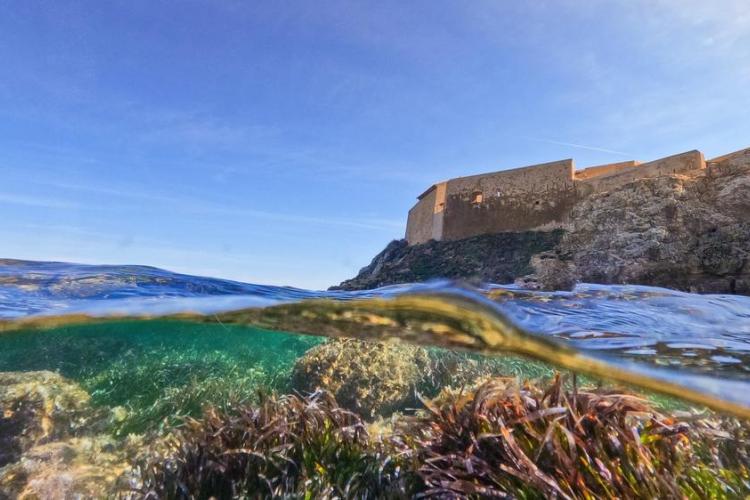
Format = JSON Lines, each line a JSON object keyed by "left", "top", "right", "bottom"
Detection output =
{"left": 0, "top": 371, "right": 92, "bottom": 467}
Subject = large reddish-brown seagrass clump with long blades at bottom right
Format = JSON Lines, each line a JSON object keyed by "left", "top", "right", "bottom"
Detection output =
{"left": 397, "top": 376, "right": 748, "bottom": 498}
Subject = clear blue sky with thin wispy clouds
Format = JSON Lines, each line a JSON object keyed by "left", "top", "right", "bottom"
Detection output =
{"left": 0, "top": 0, "right": 750, "bottom": 288}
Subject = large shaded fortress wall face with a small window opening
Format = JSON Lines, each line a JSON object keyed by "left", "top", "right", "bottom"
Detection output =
{"left": 443, "top": 159, "right": 577, "bottom": 240}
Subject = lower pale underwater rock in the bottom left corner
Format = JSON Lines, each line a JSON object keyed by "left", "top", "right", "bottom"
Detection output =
{"left": 0, "top": 436, "right": 134, "bottom": 500}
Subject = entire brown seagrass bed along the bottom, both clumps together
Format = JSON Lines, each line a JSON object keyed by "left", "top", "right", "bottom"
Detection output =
{"left": 132, "top": 376, "right": 750, "bottom": 499}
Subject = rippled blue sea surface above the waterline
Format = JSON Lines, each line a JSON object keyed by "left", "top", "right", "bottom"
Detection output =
{"left": 0, "top": 261, "right": 750, "bottom": 416}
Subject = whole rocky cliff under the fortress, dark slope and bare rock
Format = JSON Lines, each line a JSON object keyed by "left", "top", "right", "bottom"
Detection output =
{"left": 337, "top": 150, "right": 750, "bottom": 294}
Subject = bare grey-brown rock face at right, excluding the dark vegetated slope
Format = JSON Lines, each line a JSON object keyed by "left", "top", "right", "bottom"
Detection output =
{"left": 558, "top": 160, "right": 750, "bottom": 294}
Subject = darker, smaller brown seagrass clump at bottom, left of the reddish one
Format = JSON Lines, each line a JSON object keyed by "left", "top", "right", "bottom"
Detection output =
{"left": 136, "top": 392, "right": 408, "bottom": 499}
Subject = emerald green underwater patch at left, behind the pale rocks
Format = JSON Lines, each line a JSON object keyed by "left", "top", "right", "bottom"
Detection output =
{"left": 0, "top": 321, "right": 322, "bottom": 435}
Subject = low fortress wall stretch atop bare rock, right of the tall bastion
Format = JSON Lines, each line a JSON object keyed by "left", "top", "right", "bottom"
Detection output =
{"left": 578, "top": 150, "right": 706, "bottom": 194}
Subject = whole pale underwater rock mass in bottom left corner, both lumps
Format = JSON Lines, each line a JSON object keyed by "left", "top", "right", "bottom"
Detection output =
{"left": 0, "top": 371, "right": 151, "bottom": 500}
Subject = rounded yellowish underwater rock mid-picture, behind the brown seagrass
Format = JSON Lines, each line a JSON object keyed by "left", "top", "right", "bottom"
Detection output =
{"left": 292, "top": 339, "right": 430, "bottom": 419}
